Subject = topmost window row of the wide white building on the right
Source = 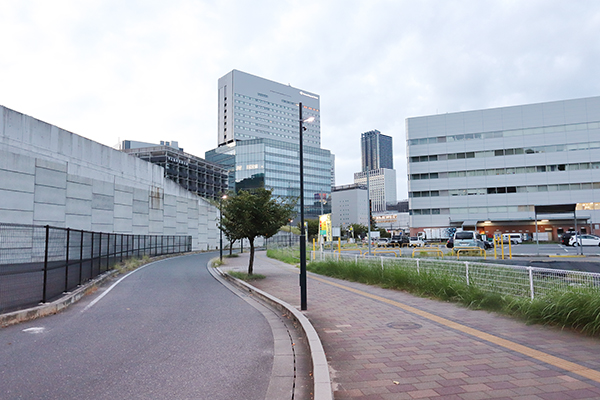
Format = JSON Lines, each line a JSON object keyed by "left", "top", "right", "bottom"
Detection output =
{"left": 408, "top": 122, "right": 600, "bottom": 146}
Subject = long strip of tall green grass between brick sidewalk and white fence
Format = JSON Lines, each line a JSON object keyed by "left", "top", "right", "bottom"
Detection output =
{"left": 307, "top": 260, "right": 600, "bottom": 336}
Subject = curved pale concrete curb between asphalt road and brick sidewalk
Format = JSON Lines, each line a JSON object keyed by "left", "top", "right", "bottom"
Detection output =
{"left": 215, "top": 268, "right": 333, "bottom": 400}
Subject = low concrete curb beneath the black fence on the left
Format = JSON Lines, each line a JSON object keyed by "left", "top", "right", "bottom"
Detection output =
{"left": 0, "top": 269, "right": 117, "bottom": 328}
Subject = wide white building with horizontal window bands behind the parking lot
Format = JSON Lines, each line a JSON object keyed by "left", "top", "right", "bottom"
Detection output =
{"left": 406, "top": 97, "right": 600, "bottom": 239}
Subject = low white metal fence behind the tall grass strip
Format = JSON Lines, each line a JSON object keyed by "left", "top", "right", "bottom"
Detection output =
{"left": 310, "top": 251, "right": 600, "bottom": 300}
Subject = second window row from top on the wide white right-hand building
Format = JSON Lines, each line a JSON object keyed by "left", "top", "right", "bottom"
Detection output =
{"left": 410, "top": 142, "right": 600, "bottom": 162}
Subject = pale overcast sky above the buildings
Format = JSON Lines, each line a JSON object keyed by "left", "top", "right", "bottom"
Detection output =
{"left": 0, "top": 0, "right": 600, "bottom": 200}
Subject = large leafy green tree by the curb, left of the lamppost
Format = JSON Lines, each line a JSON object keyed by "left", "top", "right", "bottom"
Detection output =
{"left": 221, "top": 188, "right": 296, "bottom": 275}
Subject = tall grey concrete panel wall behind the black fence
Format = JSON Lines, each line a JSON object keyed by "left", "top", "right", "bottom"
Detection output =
{"left": 0, "top": 106, "right": 218, "bottom": 250}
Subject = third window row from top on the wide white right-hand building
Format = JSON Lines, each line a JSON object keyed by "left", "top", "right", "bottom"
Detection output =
{"left": 409, "top": 162, "right": 600, "bottom": 180}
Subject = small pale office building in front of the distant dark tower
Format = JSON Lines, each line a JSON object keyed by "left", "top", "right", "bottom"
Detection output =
{"left": 354, "top": 168, "right": 398, "bottom": 212}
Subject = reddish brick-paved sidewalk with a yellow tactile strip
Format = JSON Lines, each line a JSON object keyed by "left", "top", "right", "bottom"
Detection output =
{"left": 221, "top": 252, "right": 600, "bottom": 400}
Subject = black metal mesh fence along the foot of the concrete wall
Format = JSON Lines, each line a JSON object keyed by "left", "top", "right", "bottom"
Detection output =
{"left": 0, "top": 224, "right": 192, "bottom": 313}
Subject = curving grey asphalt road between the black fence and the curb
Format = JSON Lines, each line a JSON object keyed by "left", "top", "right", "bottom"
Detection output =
{"left": 0, "top": 253, "right": 273, "bottom": 400}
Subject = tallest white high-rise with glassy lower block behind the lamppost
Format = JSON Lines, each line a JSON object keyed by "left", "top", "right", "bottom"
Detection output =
{"left": 205, "top": 70, "right": 335, "bottom": 218}
